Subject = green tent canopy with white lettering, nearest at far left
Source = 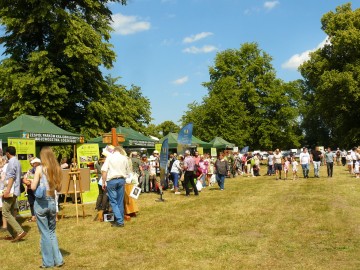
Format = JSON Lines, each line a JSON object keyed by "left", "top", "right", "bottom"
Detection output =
{"left": 0, "top": 114, "right": 83, "bottom": 144}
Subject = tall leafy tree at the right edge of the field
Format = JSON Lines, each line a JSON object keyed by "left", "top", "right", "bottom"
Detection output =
{"left": 300, "top": 4, "right": 360, "bottom": 147}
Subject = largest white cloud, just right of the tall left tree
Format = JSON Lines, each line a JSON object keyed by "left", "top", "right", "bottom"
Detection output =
{"left": 111, "top": 13, "right": 151, "bottom": 36}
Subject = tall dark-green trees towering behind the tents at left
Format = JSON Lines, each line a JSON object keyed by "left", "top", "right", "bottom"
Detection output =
{"left": 0, "top": 0, "right": 149, "bottom": 134}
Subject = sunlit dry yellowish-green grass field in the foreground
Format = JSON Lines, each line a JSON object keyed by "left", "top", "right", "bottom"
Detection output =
{"left": 0, "top": 166, "right": 360, "bottom": 270}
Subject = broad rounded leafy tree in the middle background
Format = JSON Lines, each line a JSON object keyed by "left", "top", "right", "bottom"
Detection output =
{"left": 182, "top": 43, "right": 301, "bottom": 149}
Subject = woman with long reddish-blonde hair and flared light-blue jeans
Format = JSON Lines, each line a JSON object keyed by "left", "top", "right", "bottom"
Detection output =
{"left": 31, "top": 147, "right": 64, "bottom": 268}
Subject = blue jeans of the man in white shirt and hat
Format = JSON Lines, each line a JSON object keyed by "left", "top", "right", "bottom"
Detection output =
{"left": 106, "top": 178, "right": 125, "bottom": 224}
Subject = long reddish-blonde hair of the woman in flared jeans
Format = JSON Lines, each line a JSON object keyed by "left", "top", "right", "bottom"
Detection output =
{"left": 40, "top": 146, "right": 62, "bottom": 191}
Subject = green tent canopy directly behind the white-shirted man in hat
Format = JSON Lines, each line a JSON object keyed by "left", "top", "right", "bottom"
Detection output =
{"left": 88, "top": 126, "right": 156, "bottom": 148}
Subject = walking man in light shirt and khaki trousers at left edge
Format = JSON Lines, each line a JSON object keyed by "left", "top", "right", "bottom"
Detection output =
{"left": 2, "top": 146, "right": 26, "bottom": 242}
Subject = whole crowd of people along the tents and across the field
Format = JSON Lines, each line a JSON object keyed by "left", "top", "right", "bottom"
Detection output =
{"left": 0, "top": 143, "right": 360, "bottom": 268}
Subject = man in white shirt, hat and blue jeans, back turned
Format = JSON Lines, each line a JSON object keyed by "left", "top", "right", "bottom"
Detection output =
{"left": 101, "top": 146, "right": 131, "bottom": 227}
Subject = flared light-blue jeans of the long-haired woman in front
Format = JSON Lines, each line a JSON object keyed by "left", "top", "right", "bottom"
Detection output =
{"left": 34, "top": 197, "right": 64, "bottom": 267}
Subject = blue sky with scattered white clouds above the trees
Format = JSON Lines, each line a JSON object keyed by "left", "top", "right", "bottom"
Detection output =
{"left": 105, "top": 0, "right": 360, "bottom": 124}
